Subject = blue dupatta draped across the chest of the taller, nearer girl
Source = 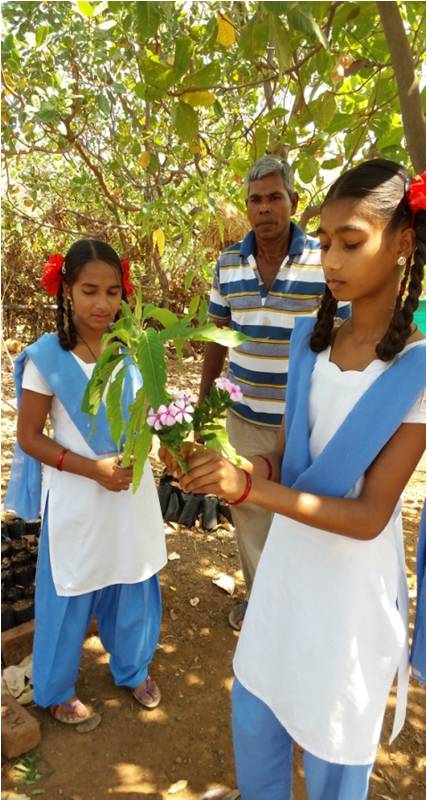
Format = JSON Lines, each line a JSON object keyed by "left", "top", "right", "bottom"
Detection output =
{"left": 281, "top": 317, "right": 426, "bottom": 498}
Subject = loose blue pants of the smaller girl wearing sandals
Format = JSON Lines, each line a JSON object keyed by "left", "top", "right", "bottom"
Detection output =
{"left": 33, "top": 510, "right": 162, "bottom": 707}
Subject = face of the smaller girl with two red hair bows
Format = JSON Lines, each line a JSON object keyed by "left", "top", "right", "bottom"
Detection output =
{"left": 65, "top": 260, "right": 122, "bottom": 333}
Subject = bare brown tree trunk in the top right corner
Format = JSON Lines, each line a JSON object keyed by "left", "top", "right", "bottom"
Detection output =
{"left": 377, "top": 2, "right": 426, "bottom": 173}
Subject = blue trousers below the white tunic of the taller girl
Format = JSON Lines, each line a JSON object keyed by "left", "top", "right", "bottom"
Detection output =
{"left": 232, "top": 679, "right": 373, "bottom": 801}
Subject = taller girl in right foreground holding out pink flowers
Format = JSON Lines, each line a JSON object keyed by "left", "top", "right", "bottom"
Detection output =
{"left": 162, "top": 159, "right": 425, "bottom": 799}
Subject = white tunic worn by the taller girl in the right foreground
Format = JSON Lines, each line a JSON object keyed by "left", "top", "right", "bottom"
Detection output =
{"left": 234, "top": 343, "right": 425, "bottom": 765}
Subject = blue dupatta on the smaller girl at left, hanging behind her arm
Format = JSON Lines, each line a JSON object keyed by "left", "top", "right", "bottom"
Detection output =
{"left": 5, "top": 334, "right": 142, "bottom": 520}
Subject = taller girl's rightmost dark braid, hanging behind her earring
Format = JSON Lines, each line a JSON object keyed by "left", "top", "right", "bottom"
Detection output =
{"left": 376, "top": 211, "right": 426, "bottom": 361}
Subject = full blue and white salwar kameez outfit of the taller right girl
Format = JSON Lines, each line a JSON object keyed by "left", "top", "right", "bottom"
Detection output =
{"left": 233, "top": 319, "right": 425, "bottom": 799}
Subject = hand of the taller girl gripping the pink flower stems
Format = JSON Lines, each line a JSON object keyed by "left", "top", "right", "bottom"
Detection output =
{"left": 179, "top": 448, "right": 246, "bottom": 501}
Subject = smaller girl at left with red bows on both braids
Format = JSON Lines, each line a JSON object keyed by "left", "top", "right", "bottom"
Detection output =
{"left": 5, "top": 239, "right": 166, "bottom": 724}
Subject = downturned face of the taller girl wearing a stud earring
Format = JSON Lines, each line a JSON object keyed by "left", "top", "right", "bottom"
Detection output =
{"left": 318, "top": 198, "right": 413, "bottom": 301}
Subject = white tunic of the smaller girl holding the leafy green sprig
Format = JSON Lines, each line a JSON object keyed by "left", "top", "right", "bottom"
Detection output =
{"left": 22, "top": 354, "right": 167, "bottom": 596}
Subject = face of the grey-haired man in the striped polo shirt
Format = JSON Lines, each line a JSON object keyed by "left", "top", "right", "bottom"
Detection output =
{"left": 246, "top": 173, "right": 298, "bottom": 240}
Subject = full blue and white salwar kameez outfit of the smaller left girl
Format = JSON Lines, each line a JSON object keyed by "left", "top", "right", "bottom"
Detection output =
{"left": 6, "top": 335, "right": 167, "bottom": 706}
